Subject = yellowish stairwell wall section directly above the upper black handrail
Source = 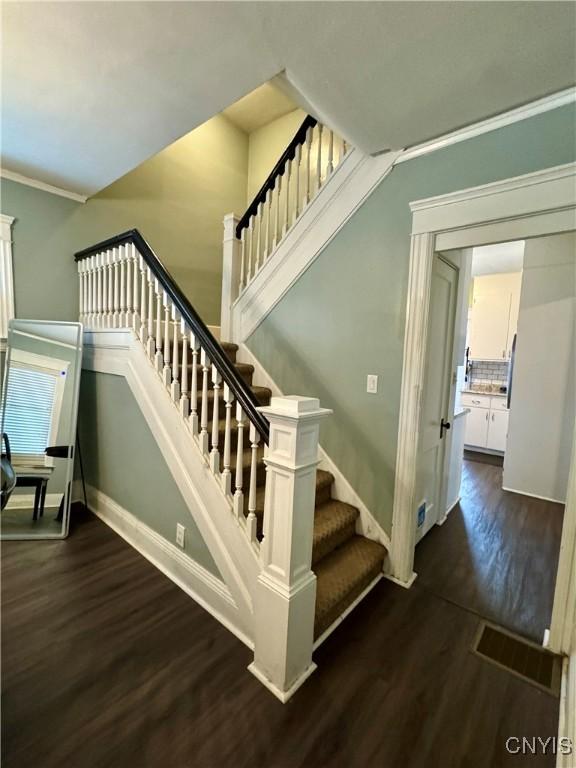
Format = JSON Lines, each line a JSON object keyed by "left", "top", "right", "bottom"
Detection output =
{"left": 242, "top": 109, "right": 306, "bottom": 204}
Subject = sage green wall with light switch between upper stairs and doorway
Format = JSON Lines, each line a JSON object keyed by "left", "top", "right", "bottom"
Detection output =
{"left": 247, "top": 105, "right": 576, "bottom": 532}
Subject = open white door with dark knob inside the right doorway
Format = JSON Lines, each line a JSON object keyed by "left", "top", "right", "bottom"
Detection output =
{"left": 415, "top": 254, "right": 458, "bottom": 539}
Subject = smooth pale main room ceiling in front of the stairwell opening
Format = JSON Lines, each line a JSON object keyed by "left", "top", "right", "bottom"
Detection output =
{"left": 0, "top": 1, "right": 576, "bottom": 195}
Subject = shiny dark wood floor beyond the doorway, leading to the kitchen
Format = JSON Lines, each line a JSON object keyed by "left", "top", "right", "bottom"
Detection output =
{"left": 414, "top": 455, "right": 564, "bottom": 643}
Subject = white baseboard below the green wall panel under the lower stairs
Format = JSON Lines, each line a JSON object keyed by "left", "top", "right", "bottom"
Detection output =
{"left": 86, "top": 485, "right": 254, "bottom": 650}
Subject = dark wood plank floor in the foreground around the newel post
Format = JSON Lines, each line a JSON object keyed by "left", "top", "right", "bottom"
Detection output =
{"left": 2, "top": 504, "right": 558, "bottom": 768}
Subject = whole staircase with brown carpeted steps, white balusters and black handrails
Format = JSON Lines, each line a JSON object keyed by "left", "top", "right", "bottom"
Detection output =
{"left": 75, "top": 118, "right": 386, "bottom": 702}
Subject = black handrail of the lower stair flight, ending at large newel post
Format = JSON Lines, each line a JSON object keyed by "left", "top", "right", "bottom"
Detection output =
{"left": 74, "top": 229, "right": 269, "bottom": 445}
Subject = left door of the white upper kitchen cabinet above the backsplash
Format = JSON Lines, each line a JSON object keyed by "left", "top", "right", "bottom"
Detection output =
{"left": 470, "top": 292, "right": 511, "bottom": 360}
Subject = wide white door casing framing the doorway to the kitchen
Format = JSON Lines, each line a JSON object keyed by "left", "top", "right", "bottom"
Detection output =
{"left": 390, "top": 163, "right": 576, "bottom": 652}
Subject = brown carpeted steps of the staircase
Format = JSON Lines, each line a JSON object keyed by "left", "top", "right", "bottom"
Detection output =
{"left": 214, "top": 342, "right": 386, "bottom": 640}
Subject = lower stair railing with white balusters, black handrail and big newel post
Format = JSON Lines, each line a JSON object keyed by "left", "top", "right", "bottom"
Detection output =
{"left": 76, "top": 230, "right": 330, "bottom": 701}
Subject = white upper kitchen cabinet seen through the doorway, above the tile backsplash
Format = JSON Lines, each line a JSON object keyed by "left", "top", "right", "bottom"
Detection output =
{"left": 468, "top": 272, "right": 522, "bottom": 360}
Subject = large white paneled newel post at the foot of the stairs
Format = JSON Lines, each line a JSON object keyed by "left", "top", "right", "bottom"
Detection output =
{"left": 248, "top": 396, "right": 332, "bottom": 701}
